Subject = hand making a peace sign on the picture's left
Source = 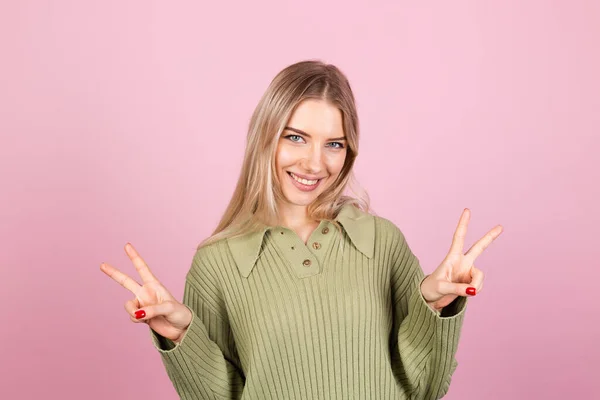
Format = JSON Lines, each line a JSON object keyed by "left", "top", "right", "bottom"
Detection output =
{"left": 100, "top": 243, "right": 192, "bottom": 343}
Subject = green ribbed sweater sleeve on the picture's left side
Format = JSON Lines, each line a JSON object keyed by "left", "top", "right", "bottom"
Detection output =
{"left": 150, "top": 248, "right": 245, "bottom": 400}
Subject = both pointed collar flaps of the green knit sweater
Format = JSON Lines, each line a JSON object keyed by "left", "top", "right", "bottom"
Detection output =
{"left": 227, "top": 204, "right": 375, "bottom": 278}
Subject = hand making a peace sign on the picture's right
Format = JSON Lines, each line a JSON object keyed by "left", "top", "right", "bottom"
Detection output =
{"left": 421, "top": 208, "right": 503, "bottom": 311}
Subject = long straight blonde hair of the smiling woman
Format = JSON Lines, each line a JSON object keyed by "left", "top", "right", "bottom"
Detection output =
{"left": 198, "top": 60, "right": 369, "bottom": 249}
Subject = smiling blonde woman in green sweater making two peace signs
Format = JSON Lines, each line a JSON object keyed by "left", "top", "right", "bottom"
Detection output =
{"left": 101, "top": 61, "right": 502, "bottom": 399}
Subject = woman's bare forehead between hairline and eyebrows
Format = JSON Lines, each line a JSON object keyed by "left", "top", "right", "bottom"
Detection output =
{"left": 287, "top": 99, "right": 344, "bottom": 136}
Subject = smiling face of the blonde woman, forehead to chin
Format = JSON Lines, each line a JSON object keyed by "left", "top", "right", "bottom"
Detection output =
{"left": 275, "top": 99, "right": 347, "bottom": 206}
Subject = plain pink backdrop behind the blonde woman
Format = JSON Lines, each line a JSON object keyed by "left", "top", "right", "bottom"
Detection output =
{"left": 0, "top": 0, "right": 600, "bottom": 399}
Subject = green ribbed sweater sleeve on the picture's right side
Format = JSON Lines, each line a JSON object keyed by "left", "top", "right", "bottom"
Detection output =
{"left": 390, "top": 222, "right": 467, "bottom": 400}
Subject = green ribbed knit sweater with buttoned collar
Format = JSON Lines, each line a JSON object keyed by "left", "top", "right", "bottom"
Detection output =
{"left": 150, "top": 205, "right": 467, "bottom": 400}
